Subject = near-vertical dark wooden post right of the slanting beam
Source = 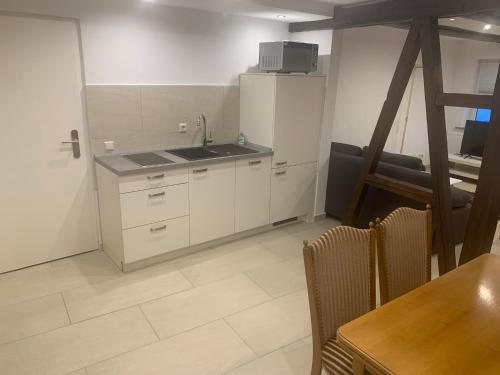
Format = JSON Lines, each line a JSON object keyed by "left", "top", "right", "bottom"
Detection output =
{"left": 420, "top": 17, "right": 456, "bottom": 275}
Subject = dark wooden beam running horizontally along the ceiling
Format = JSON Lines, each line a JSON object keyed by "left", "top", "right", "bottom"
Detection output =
{"left": 289, "top": 0, "right": 500, "bottom": 32}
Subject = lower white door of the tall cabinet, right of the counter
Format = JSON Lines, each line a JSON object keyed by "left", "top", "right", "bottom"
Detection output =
{"left": 271, "top": 163, "right": 316, "bottom": 223}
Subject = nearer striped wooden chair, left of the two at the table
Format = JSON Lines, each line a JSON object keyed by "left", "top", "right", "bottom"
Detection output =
{"left": 304, "top": 227, "right": 376, "bottom": 375}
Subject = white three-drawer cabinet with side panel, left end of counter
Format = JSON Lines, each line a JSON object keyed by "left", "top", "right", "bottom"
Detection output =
{"left": 96, "top": 164, "right": 189, "bottom": 269}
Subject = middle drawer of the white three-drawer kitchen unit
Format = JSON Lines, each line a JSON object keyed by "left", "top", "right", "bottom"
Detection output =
{"left": 120, "top": 184, "right": 189, "bottom": 229}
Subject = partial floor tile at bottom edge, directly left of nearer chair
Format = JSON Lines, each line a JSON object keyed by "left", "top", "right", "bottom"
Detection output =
{"left": 227, "top": 340, "right": 312, "bottom": 375}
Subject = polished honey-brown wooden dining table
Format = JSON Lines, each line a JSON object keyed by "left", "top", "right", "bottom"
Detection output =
{"left": 337, "top": 254, "right": 500, "bottom": 375}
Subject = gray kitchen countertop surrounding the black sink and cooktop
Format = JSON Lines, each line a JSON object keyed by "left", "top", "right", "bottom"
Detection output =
{"left": 95, "top": 144, "right": 274, "bottom": 176}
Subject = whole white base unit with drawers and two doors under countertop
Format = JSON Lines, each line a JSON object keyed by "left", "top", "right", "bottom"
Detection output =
{"left": 96, "top": 155, "right": 273, "bottom": 271}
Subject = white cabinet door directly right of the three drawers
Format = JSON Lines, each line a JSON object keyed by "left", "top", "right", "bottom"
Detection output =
{"left": 189, "top": 161, "right": 235, "bottom": 246}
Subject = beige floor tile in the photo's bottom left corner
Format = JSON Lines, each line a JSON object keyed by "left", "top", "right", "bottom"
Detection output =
{"left": 0, "top": 307, "right": 158, "bottom": 375}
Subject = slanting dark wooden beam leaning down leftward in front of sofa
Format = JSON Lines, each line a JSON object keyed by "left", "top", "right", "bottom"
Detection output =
{"left": 344, "top": 21, "right": 420, "bottom": 226}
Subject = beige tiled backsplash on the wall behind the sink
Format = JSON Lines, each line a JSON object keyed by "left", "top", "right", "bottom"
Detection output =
{"left": 87, "top": 85, "right": 240, "bottom": 155}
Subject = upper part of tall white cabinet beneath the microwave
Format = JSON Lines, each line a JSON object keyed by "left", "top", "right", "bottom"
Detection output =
{"left": 240, "top": 73, "right": 325, "bottom": 168}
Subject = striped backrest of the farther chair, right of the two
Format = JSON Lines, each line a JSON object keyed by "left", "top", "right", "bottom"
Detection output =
{"left": 375, "top": 207, "right": 432, "bottom": 304}
